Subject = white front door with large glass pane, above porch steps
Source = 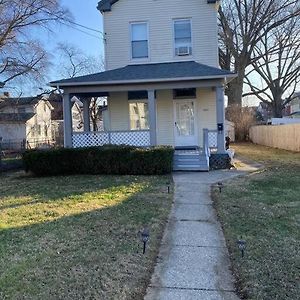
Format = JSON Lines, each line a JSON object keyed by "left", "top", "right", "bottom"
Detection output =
{"left": 174, "top": 100, "right": 197, "bottom": 147}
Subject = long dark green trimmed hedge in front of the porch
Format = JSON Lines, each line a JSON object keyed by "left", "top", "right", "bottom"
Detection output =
{"left": 23, "top": 146, "right": 174, "bottom": 176}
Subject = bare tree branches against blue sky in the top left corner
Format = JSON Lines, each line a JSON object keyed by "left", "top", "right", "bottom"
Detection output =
{"left": 0, "top": 0, "right": 69, "bottom": 86}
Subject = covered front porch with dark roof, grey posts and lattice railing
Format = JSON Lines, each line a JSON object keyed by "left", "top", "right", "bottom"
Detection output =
{"left": 52, "top": 62, "right": 236, "bottom": 170}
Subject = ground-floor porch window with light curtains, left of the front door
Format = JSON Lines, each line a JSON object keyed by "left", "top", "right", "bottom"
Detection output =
{"left": 129, "top": 101, "right": 149, "bottom": 130}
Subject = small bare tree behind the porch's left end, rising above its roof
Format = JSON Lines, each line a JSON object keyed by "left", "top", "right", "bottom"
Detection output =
{"left": 57, "top": 43, "right": 104, "bottom": 131}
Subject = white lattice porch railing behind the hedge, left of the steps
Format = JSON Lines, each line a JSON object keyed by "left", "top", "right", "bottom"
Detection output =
{"left": 72, "top": 130, "right": 150, "bottom": 148}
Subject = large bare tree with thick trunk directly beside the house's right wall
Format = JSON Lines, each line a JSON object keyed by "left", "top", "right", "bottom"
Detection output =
{"left": 219, "top": 0, "right": 300, "bottom": 105}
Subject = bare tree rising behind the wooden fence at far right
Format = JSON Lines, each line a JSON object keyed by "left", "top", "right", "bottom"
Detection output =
{"left": 245, "top": 19, "right": 300, "bottom": 118}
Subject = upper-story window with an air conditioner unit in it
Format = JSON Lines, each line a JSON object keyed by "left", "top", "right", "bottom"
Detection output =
{"left": 174, "top": 19, "right": 192, "bottom": 56}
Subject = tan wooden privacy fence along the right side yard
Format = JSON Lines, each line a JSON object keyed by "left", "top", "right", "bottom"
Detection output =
{"left": 250, "top": 124, "right": 300, "bottom": 152}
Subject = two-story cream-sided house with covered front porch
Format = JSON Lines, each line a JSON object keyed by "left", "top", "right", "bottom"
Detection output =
{"left": 50, "top": 0, "right": 235, "bottom": 170}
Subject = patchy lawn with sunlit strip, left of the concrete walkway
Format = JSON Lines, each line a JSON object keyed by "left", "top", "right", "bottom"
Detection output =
{"left": 0, "top": 172, "right": 172, "bottom": 299}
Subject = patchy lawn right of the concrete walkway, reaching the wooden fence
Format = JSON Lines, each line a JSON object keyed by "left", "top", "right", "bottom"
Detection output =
{"left": 213, "top": 144, "right": 300, "bottom": 300}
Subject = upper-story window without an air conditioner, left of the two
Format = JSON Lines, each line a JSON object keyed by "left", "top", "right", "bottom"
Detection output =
{"left": 131, "top": 23, "right": 148, "bottom": 59}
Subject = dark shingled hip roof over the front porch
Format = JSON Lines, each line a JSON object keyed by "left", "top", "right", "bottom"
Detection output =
{"left": 50, "top": 61, "right": 236, "bottom": 93}
